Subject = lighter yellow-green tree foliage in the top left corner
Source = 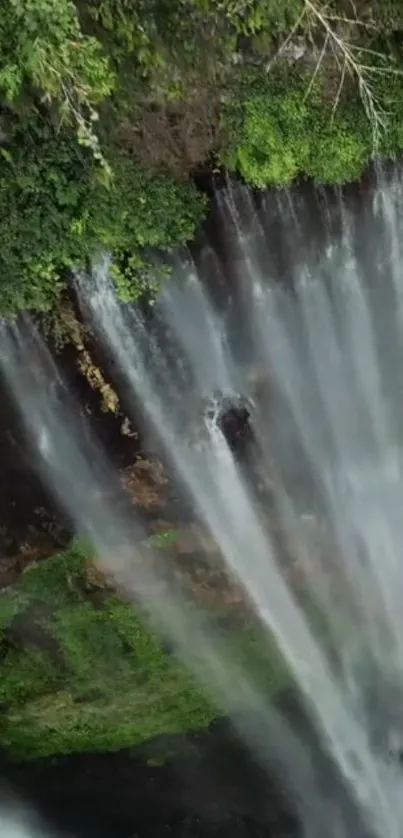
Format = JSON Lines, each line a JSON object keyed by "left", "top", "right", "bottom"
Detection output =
{"left": 0, "top": 0, "right": 114, "bottom": 159}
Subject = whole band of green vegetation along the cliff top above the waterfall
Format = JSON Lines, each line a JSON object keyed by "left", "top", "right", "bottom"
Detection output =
{"left": 0, "top": 0, "right": 403, "bottom": 314}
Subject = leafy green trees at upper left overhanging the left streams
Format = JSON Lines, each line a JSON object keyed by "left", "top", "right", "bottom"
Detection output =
{"left": 0, "top": 0, "right": 211, "bottom": 314}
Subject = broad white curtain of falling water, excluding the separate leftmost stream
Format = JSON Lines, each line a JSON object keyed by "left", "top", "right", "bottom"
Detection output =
{"left": 74, "top": 167, "right": 403, "bottom": 838}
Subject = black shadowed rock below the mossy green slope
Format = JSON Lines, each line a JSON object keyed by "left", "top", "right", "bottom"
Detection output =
{"left": 0, "top": 719, "right": 299, "bottom": 838}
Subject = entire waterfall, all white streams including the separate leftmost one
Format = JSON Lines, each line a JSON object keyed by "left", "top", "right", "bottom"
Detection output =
{"left": 2, "top": 167, "right": 403, "bottom": 838}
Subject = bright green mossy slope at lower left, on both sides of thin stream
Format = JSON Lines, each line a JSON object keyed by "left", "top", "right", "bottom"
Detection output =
{"left": 0, "top": 543, "right": 289, "bottom": 758}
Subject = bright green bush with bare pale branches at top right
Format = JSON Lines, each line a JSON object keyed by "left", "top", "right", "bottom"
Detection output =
{"left": 221, "top": 0, "right": 403, "bottom": 188}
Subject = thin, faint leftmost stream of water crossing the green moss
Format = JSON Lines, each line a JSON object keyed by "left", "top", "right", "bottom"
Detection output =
{"left": 0, "top": 319, "right": 348, "bottom": 838}
